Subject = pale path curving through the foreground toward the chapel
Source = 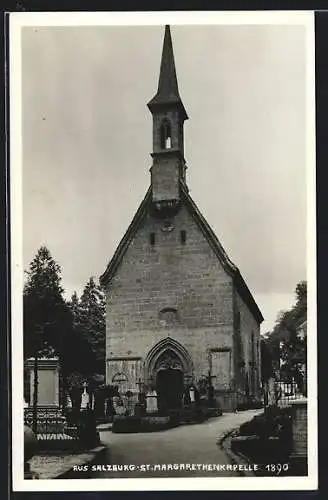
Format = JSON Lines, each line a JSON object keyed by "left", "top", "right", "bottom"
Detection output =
{"left": 30, "top": 410, "right": 263, "bottom": 479}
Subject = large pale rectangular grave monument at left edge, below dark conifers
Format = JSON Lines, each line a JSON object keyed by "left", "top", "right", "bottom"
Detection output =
{"left": 26, "top": 358, "right": 59, "bottom": 408}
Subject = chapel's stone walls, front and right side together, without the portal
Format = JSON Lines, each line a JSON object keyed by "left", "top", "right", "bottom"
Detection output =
{"left": 102, "top": 199, "right": 260, "bottom": 408}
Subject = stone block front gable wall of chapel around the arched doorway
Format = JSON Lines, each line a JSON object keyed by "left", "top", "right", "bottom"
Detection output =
{"left": 106, "top": 201, "right": 233, "bottom": 396}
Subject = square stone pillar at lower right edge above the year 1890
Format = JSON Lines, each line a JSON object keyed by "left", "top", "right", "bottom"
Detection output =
{"left": 290, "top": 398, "right": 308, "bottom": 474}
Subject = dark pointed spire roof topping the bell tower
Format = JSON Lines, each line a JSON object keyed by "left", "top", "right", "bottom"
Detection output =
{"left": 148, "top": 24, "right": 187, "bottom": 118}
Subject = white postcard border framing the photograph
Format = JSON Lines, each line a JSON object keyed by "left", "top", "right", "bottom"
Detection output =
{"left": 9, "top": 11, "right": 318, "bottom": 491}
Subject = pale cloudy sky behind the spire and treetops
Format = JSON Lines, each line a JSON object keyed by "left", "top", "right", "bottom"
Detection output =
{"left": 22, "top": 24, "right": 306, "bottom": 332}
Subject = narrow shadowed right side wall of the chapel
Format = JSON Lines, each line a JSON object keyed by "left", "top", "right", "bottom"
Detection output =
{"left": 234, "top": 291, "right": 261, "bottom": 397}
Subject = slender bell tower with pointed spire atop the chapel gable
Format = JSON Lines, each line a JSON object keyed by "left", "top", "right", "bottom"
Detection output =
{"left": 148, "top": 25, "right": 188, "bottom": 210}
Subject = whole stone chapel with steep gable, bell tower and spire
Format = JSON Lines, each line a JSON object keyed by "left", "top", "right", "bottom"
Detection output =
{"left": 100, "top": 26, "right": 263, "bottom": 411}
